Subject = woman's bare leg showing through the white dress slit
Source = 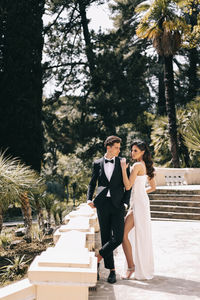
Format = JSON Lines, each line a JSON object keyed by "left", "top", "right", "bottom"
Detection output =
{"left": 122, "top": 212, "right": 135, "bottom": 279}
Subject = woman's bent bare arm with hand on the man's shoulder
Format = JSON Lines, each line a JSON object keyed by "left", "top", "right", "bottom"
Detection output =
{"left": 121, "top": 158, "right": 141, "bottom": 191}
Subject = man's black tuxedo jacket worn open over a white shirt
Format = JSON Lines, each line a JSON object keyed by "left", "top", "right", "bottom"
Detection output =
{"left": 87, "top": 157, "right": 131, "bottom": 208}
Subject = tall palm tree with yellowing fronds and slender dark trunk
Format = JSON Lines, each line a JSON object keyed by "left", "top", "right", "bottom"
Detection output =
{"left": 136, "top": 0, "right": 188, "bottom": 167}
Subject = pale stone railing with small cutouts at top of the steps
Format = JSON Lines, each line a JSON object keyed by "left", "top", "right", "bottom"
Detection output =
{"left": 155, "top": 168, "right": 200, "bottom": 186}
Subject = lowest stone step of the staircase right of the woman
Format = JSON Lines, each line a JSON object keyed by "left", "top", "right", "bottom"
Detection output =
{"left": 151, "top": 211, "right": 200, "bottom": 221}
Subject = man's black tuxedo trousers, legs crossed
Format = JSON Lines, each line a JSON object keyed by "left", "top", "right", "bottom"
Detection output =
{"left": 97, "top": 197, "right": 124, "bottom": 269}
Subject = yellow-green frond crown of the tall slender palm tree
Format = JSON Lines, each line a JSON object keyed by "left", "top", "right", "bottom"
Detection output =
{"left": 135, "top": 0, "right": 189, "bottom": 56}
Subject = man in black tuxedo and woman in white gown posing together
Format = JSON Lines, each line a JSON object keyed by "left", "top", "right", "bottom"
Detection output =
{"left": 87, "top": 136, "right": 155, "bottom": 283}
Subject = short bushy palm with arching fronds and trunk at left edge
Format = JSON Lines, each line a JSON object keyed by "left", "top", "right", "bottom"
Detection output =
{"left": 0, "top": 153, "right": 41, "bottom": 236}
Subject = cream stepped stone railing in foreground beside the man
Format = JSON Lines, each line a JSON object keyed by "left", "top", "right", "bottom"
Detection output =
{"left": 0, "top": 204, "right": 99, "bottom": 300}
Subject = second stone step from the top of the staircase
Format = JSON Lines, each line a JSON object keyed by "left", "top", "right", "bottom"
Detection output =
{"left": 148, "top": 193, "right": 200, "bottom": 201}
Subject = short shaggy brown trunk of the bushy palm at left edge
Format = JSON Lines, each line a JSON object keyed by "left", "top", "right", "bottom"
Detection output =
{"left": 21, "top": 193, "right": 32, "bottom": 242}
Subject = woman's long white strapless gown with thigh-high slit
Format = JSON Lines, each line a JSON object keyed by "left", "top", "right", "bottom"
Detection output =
{"left": 126, "top": 175, "right": 154, "bottom": 280}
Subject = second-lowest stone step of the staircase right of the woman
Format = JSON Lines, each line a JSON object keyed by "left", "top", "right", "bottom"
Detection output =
{"left": 150, "top": 205, "right": 200, "bottom": 215}
